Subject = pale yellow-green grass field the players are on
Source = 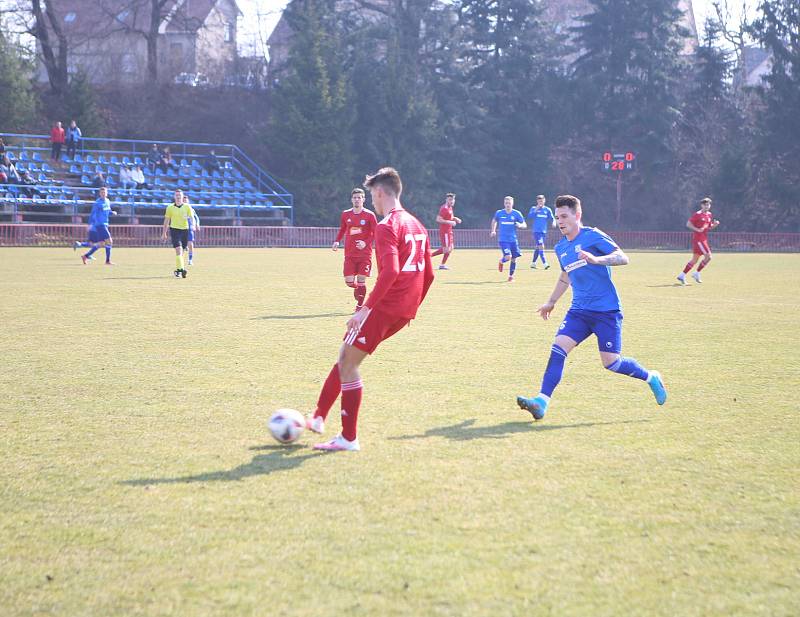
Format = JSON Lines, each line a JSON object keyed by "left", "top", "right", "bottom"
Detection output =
{"left": 0, "top": 248, "right": 800, "bottom": 617}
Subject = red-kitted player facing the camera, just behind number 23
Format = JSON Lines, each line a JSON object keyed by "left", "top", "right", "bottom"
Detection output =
{"left": 331, "top": 189, "right": 378, "bottom": 310}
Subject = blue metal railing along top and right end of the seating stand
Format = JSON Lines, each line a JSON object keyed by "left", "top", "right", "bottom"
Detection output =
{"left": 0, "top": 133, "right": 294, "bottom": 224}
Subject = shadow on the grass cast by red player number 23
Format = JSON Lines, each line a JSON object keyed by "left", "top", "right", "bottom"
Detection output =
{"left": 120, "top": 445, "right": 322, "bottom": 486}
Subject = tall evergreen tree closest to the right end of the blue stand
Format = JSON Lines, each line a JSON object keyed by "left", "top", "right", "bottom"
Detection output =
{"left": 265, "top": 0, "right": 354, "bottom": 225}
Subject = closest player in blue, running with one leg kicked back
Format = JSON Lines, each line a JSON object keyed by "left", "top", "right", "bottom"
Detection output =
{"left": 517, "top": 195, "right": 667, "bottom": 420}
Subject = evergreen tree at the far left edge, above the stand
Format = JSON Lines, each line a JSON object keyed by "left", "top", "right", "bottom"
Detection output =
{"left": 0, "top": 32, "right": 37, "bottom": 133}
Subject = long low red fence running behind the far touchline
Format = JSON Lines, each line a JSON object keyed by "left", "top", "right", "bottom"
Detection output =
{"left": 0, "top": 224, "right": 800, "bottom": 252}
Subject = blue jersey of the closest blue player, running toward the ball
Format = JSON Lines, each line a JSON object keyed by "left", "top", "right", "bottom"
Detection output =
{"left": 553, "top": 227, "right": 621, "bottom": 311}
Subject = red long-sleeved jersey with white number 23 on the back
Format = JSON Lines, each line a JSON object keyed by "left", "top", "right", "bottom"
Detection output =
{"left": 366, "top": 207, "right": 433, "bottom": 319}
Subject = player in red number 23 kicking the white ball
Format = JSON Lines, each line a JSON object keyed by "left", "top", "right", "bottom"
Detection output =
{"left": 307, "top": 167, "right": 433, "bottom": 450}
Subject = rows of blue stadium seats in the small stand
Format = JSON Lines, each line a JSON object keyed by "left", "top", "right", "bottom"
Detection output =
{"left": 0, "top": 135, "right": 292, "bottom": 225}
